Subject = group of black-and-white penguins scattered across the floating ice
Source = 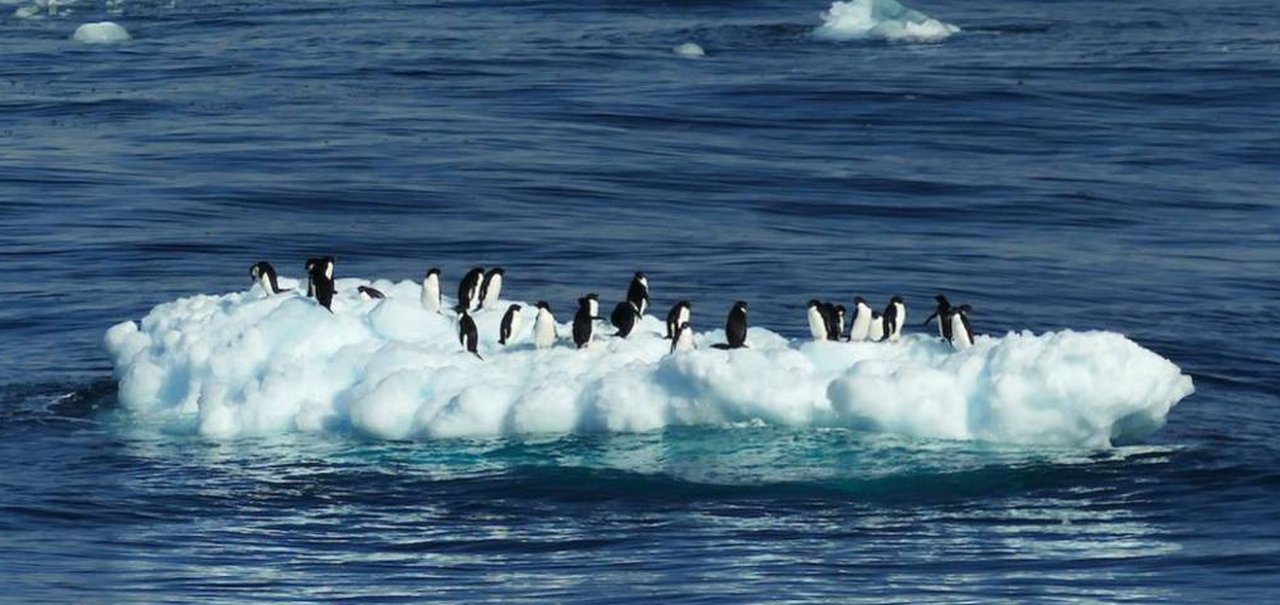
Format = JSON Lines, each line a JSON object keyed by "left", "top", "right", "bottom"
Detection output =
{"left": 248, "top": 256, "right": 973, "bottom": 359}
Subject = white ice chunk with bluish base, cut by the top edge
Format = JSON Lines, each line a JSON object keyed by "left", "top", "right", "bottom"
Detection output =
{"left": 814, "top": 0, "right": 960, "bottom": 42}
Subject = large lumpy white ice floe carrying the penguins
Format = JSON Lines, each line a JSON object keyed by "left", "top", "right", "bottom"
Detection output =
{"left": 105, "top": 278, "right": 1193, "bottom": 446}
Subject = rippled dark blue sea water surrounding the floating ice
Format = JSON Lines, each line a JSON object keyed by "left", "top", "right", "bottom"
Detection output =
{"left": 0, "top": 0, "right": 1280, "bottom": 602}
